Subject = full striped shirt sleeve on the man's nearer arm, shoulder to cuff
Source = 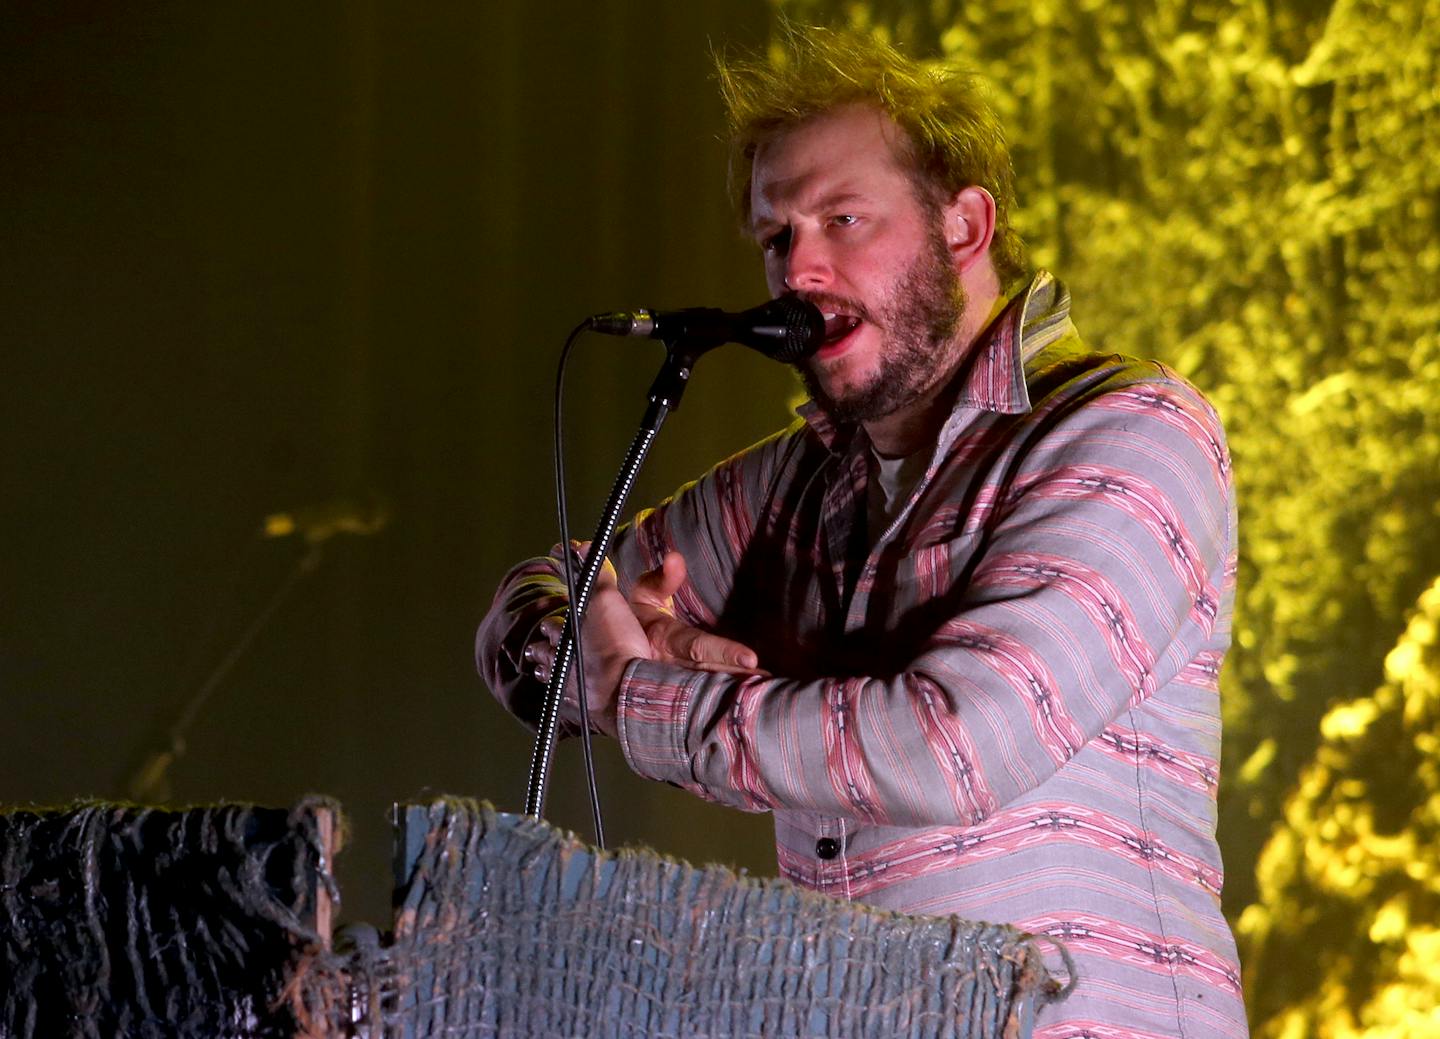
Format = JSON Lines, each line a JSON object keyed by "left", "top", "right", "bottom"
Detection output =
{"left": 619, "top": 378, "right": 1234, "bottom": 826}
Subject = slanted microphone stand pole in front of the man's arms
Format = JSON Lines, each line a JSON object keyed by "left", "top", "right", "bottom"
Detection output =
{"left": 526, "top": 340, "right": 710, "bottom": 819}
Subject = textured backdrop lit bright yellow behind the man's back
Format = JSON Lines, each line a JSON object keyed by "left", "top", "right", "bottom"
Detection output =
{"left": 782, "top": 0, "right": 1440, "bottom": 1039}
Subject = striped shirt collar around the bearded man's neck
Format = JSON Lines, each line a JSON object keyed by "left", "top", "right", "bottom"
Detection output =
{"left": 795, "top": 271, "right": 1071, "bottom": 450}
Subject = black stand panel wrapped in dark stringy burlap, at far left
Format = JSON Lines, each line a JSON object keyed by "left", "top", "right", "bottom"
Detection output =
{"left": 0, "top": 800, "right": 338, "bottom": 1039}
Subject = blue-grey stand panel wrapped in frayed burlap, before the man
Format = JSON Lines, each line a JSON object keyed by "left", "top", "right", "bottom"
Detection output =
{"left": 324, "top": 800, "right": 1058, "bottom": 1039}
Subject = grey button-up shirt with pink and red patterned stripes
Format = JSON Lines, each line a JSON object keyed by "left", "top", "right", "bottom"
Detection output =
{"left": 477, "top": 273, "right": 1246, "bottom": 1039}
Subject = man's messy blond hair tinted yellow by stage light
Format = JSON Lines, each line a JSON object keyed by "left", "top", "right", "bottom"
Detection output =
{"left": 716, "top": 20, "right": 1027, "bottom": 285}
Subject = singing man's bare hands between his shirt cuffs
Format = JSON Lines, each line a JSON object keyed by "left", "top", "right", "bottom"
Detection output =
{"left": 526, "top": 545, "right": 765, "bottom": 735}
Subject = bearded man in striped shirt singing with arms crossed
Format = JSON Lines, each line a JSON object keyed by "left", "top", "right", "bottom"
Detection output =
{"left": 477, "top": 29, "right": 1246, "bottom": 1039}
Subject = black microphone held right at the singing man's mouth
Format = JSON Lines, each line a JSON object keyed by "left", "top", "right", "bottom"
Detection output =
{"left": 586, "top": 296, "right": 825, "bottom": 364}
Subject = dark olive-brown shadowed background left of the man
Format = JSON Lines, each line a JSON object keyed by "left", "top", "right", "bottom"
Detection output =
{"left": 0, "top": 0, "right": 793, "bottom": 924}
